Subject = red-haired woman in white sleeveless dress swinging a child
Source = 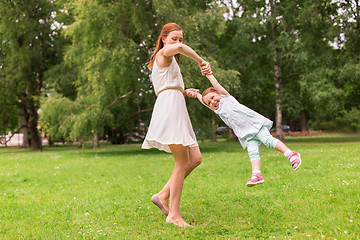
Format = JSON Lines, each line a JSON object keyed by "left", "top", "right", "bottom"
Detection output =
{"left": 142, "top": 23, "right": 211, "bottom": 227}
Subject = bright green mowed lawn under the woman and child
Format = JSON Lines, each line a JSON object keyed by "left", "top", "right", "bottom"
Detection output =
{"left": 0, "top": 135, "right": 360, "bottom": 240}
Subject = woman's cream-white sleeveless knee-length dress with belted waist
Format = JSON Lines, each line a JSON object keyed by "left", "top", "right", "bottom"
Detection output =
{"left": 142, "top": 57, "right": 198, "bottom": 153}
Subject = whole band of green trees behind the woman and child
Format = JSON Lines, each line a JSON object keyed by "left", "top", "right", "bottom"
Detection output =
{"left": 0, "top": 0, "right": 360, "bottom": 149}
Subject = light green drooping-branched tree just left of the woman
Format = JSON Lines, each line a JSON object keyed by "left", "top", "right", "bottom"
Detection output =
{"left": 40, "top": 1, "right": 156, "bottom": 147}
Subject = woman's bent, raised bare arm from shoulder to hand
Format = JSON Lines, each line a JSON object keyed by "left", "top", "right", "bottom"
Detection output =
{"left": 159, "top": 43, "right": 212, "bottom": 75}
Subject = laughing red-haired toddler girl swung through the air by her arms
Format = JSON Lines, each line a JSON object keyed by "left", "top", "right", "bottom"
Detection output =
{"left": 187, "top": 75, "right": 301, "bottom": 187}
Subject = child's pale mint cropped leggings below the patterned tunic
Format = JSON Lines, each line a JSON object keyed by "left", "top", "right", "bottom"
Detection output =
{"left": 247, "top": 127, "right": 279, "bottom": 161}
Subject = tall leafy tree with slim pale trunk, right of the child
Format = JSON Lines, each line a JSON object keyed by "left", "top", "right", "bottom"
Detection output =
{"left": 218, "top": 1, "right": 348, "bottom": 139}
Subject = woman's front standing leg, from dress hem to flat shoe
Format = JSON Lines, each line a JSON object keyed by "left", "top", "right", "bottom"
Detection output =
{"left": 166, "top": 145, "right": 190, "bottom": 227}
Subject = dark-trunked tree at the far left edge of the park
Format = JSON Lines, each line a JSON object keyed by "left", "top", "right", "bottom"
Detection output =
{"left": 0, "top": 0, "right": 61, "bottom": 149}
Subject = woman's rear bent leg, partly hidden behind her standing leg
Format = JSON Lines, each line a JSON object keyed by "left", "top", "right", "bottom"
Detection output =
{"left": 153, "top": 147, "right": 202, "bottom": 215}
